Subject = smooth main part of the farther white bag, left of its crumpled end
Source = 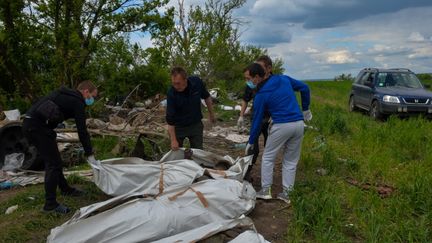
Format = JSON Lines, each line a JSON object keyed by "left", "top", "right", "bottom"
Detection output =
{"left": 92, "top": 158, "right": 204, "bottom": 196}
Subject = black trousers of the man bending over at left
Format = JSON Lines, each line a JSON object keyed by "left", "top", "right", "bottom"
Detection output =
{"left": 23, "top": 118, "right": 72, "bottom": 210}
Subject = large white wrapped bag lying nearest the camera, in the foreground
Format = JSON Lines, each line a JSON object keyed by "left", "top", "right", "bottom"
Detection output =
{"left": 48, "top": 179, "right": 255, "bottom": 242}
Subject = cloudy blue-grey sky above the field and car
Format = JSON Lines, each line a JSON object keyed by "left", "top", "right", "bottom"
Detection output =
{"left": 137, "top": 0, "right": 432, "bottom": 79}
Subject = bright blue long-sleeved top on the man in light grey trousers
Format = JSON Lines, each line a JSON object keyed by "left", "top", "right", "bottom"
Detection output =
{"left": 249, "top": 75, "right": 310, "bottom": 144}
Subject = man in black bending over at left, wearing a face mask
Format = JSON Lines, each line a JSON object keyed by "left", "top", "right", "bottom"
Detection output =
{"left": 23, "top": 81, "right": 98, "bottom": 214}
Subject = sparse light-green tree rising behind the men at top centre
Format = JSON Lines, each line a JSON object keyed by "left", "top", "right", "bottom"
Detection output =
{"left": 155, "top": 0, "right": 274, "bottom": 87}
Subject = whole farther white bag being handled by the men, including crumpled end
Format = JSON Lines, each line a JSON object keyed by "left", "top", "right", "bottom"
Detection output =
{"left": 92, "top": 149, "right": 252, "bottom": 196}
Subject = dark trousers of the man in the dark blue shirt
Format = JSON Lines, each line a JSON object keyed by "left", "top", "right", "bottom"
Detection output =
{"left": 175, "top": 121, "right": 204, "bottom": 149}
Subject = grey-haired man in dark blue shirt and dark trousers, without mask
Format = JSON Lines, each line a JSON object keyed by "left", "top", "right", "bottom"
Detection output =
{"left": 166, "top": 67, "right": 215, "bottom": 150}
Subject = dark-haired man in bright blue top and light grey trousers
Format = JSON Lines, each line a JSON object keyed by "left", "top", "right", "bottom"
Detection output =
{"left": 245, "top": 63, "right": 312, "bottom": 203}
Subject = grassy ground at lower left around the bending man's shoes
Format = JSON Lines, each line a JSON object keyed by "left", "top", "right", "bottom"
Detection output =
{"left": 0, "top": 175, "right": 108, "bottom": 242}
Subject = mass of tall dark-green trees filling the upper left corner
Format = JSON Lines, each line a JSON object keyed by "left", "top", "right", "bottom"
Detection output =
{"left": 0, "top": 0, "right": 172, "bottom": 103}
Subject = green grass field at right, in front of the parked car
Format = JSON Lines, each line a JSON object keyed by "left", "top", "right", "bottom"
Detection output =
{"left": 287, "top": 82, "right": 432, "bottom": 242}
